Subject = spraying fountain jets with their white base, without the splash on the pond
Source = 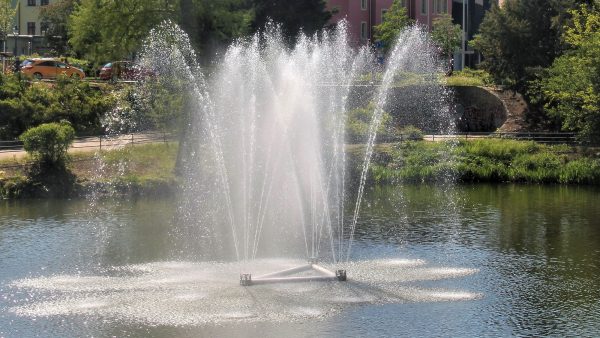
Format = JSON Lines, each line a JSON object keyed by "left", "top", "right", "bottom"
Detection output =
{"left": 141, "top": 23, "right": 447, "bottom": 286}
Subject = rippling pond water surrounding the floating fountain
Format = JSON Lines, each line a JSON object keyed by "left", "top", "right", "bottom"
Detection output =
{"left": 0, "top": 185, "right": 600, "bottom": 337}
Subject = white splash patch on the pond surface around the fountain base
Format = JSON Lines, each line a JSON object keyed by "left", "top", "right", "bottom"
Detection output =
{"left": 9, "top": 259, "right": 480, "bottom": 326}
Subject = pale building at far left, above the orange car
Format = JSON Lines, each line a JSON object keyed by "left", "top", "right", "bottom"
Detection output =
{"left": 6, "top": 0, "right": 58, "bottom": 55}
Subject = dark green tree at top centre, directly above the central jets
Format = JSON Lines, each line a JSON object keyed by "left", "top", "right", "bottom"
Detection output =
{"left": 251, "top": 0, "right": 331, "bottom": 39}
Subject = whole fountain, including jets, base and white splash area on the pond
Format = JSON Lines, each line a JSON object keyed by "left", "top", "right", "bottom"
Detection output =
{"left": 2, "top": 23, "right": 481, "bottom": 332}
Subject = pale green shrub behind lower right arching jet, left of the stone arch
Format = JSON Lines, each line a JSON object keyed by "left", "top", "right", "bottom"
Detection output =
{"left": 346, "top": 102, "right": 396, "bottom": 143}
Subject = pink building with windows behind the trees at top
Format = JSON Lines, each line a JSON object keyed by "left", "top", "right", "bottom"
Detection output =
{"left": 327, "top": 0, "right": 452, "bottom": 45}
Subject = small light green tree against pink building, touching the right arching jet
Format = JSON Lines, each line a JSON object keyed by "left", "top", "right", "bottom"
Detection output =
{"left": 373, "top": 0, "right": 413, "bottom": 52}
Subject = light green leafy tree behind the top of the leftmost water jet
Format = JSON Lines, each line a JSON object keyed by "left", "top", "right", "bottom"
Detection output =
{"left": 69, "top": 0, "right": 177, "bottom": 62}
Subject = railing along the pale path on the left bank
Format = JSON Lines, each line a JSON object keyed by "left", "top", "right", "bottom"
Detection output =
{"left": 0, "top": 132, "right": 172, "bottom": 153}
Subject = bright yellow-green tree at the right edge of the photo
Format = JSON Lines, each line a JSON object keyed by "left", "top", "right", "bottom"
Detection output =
{"left": 541, "top": 6, "right": 600, "bottom": 143}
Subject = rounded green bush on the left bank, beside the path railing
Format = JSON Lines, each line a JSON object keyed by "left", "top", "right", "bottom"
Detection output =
{"left": 19, "top": 122, "right": 75, "bottom": 164}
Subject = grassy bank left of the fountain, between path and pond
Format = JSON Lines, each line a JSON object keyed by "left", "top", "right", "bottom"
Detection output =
{"left": 0, "top": 143, "right": 178, "bottom": 198}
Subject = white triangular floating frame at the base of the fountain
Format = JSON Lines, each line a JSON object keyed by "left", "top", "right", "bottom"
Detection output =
{"left": 240, "top": 258, "right": 346, "bottom": 286}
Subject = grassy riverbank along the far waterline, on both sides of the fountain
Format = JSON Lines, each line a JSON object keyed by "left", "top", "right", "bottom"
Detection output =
{"left": 0, "top": 139, "right": 600, "bottom": 198}
